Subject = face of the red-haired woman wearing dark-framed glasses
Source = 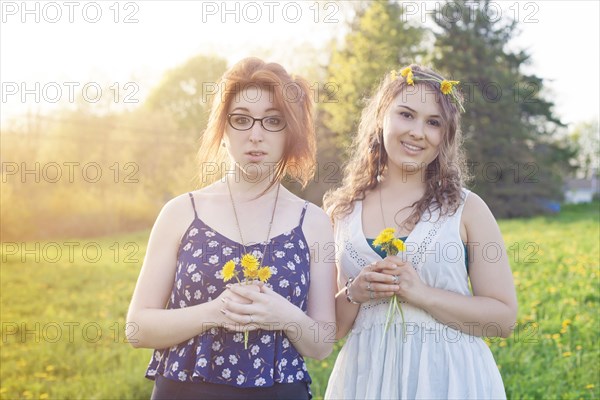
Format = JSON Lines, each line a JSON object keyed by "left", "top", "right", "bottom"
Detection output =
{"left": 223, "top": 87, "right": 286, "bottom": 181}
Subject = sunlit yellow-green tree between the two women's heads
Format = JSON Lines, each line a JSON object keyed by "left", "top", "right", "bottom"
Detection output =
{"left": 322, "top": 0, "right": 424, "bottom": 149}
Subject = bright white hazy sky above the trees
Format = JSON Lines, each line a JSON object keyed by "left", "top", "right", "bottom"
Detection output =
{"left": 0, "top": 0, "right": 600, "bottom": 125}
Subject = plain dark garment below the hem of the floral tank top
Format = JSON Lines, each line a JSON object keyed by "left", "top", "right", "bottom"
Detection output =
{"left": 152, "top": 375, "right": 312, "bottom": 400}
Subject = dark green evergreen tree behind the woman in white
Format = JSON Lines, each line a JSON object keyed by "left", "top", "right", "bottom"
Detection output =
{"left": 432, "top": 0, "right": 571, "bottom": 217}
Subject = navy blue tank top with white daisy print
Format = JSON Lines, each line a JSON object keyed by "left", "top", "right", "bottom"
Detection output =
{"left": 146, "top": 193, "right": 312, "bottom": 387}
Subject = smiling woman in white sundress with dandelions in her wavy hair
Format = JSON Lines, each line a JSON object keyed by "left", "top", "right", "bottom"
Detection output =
{"left": 324, "top": 65, "right": 517, "bottom": 399}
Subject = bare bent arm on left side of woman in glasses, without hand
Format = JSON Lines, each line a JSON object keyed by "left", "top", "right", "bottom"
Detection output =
{"left": 126, "top": 195, "right": 233, "bottom": 349}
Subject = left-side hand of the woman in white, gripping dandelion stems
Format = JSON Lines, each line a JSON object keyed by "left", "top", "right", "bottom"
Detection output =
{"left": 348, "top": 260, "right": 400, "bottom": 303}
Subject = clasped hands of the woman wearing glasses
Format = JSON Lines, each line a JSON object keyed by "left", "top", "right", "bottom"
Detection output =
{"left": 221, "top": 283, "right": 302, "bottom": 332}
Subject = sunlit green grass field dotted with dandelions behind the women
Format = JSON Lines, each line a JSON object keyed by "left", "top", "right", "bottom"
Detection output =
{"left": 0, "top": 203, "right": 600, "bottom": 399}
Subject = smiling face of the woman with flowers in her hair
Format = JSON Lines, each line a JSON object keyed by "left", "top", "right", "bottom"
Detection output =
{"left": 383, "top": 84, "right": 444, "bottom": 172}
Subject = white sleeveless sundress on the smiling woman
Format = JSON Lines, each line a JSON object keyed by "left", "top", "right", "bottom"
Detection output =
{"left": 325, "top": 189, "right": 506, "bottom": 400}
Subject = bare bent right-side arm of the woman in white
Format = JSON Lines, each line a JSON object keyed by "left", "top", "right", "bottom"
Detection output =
{"left": 386, "top": 193, "right": 517, "bottom": 337}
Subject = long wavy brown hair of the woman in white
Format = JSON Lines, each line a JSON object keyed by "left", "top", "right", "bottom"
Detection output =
{"left": 323, "top": 64, "right": 467, "bottom": 229}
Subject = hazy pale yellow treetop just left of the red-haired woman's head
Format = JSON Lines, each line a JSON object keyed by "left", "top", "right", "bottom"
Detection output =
{"left": 146, "top": 55, "right": 227, "bottom": 137}
